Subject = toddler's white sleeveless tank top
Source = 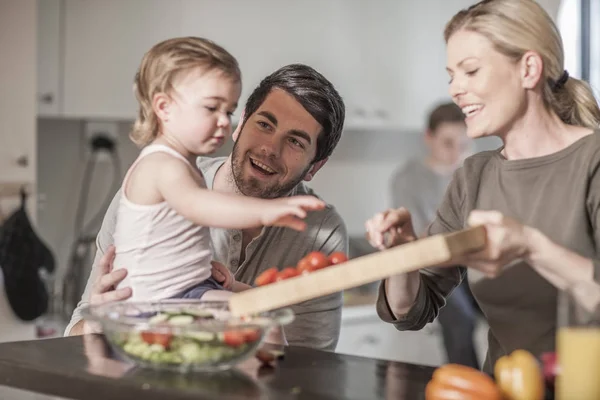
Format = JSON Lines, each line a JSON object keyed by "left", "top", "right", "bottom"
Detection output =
{"left": 114, "top": 144, "right": 212, "bottom": 301}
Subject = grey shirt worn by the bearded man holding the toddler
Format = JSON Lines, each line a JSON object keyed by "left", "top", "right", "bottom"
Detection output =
{"left": 66, "top": 157, "right": 348, "bottom": 350}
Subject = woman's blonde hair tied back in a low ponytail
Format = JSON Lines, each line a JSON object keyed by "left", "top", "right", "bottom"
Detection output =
{"left": 444, "top": 0, "right": 600, "bottom": 129}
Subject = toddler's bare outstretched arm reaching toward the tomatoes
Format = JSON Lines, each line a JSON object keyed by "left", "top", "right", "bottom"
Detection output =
{"left": 156, "top": 158, "right": 324, "bottom": 230}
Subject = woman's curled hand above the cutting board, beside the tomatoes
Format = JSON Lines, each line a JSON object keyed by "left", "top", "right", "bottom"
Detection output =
{"left": 365, "top": 208, "right": 417, "bottom": 250}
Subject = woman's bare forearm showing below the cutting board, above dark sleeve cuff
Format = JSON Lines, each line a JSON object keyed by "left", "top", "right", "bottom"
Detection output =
{"left": 385, "top": 271, "right": 421, "bottom": 319}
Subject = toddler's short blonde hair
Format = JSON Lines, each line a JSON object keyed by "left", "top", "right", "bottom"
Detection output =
{"left": 129, "top": 37, "right": 242, "bottom": 147}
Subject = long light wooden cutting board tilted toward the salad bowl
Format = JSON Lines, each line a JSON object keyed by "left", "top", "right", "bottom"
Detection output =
{"left": 229, "top": 226, "right": 486, "bottom": 316}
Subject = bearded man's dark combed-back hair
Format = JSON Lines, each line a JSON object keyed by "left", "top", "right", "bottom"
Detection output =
{"left": 244, "top": 64, "right": 345, "bottom": 162}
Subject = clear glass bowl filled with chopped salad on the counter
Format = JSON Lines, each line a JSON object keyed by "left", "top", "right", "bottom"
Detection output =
{"left": 83, "top": 300, "right": 294, "bottom": 372}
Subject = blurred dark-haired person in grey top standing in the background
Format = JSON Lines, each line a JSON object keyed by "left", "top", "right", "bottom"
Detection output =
{"left": 391, "top": 103, "right": 479, "bottom": 368}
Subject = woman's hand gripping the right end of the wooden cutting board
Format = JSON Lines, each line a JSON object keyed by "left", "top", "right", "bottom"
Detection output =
{"left": 461, "top": 210, "right": 535, "bottom": 278}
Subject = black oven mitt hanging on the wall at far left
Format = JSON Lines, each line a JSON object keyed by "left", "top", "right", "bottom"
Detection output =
{"left": 0, "top": 192, "right": 54, "bottom": 321}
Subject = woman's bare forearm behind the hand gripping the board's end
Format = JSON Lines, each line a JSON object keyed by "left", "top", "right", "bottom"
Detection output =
{"left": 526, "top": 230, "right": 594, "bottom": 289}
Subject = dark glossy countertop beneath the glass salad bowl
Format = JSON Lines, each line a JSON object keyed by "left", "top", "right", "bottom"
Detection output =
{"left": 0, "top": 335, "right": 434, "bottom": 400}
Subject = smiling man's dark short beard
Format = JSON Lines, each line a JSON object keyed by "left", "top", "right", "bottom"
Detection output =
{"left": 231, "top": 142, "right": 311, "bottom": 199}
